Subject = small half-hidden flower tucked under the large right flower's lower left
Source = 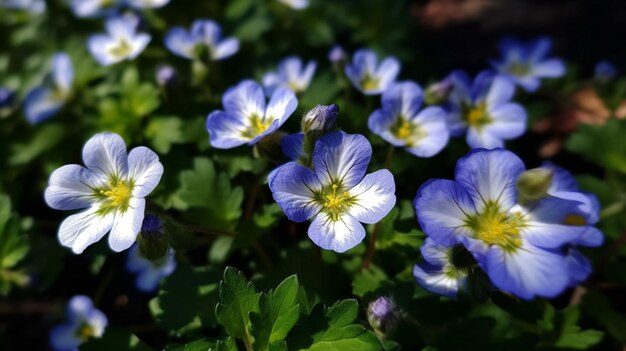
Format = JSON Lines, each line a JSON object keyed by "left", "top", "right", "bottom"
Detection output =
{"left": 413, "top": 238, "right": 467, "bottom": 298}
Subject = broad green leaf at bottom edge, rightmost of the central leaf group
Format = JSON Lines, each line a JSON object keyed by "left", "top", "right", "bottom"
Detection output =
{"left": 287, "top": 300, "right": 382, "bottom": 351}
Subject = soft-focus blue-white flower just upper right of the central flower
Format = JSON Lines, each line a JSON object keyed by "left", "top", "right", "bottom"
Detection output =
{"left": 368, "top": 82, "right": 450, "bottom": 157}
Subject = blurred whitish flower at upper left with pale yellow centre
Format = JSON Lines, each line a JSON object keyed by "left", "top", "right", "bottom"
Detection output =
{"left": 87, "top": 15, "right": 152, "bottom": 66}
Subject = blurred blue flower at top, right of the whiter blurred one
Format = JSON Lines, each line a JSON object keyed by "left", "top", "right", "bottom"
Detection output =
{"left": 165, "top": 19, "right": 239, "bottom": 61}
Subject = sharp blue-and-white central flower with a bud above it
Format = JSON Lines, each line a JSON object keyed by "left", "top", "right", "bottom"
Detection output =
{"left": 268, "top": 132, "right": 396, "bottom": 252}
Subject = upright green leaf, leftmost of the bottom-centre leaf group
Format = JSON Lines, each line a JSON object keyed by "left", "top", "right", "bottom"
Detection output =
{"left": 215, "top": 267, "right": 260, "bottom": 345}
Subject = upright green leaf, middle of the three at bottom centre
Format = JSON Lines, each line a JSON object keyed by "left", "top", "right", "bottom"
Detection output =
{"left": 250, "top": 275, "right": 300, "bottom": 351}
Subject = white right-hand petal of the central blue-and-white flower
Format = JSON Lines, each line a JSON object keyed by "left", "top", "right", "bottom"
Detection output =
{"left": 348, "top": 169, "right": 396, "bottom": 224}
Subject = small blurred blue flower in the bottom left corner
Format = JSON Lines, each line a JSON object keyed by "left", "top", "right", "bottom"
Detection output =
{"left": 50, "top": 295, "right": 108, "bottom": 351}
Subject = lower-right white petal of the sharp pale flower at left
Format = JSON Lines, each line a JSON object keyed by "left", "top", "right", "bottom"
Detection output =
{"left": 109, "top": 197, "right": 146, "bottom": 252}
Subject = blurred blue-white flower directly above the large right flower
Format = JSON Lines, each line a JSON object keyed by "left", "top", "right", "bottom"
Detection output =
{"left": 448, "top": 71, "right": 526, "bottom": 149}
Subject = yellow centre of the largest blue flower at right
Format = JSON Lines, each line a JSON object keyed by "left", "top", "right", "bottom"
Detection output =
{"left": 465, "top": 202, "right": 526, "bottom": 251}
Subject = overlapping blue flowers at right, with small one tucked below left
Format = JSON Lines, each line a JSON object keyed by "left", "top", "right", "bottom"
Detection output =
{"left": 414, "top": 149, "right": 602, "bottom": 299}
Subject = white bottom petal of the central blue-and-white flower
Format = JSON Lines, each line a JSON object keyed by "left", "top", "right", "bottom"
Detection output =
{"left": 309, "top": 212, "right": 365, "bottom": 253}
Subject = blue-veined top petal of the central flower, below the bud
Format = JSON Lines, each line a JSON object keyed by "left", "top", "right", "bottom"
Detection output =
{"left": 313, "top": 132, "right": 372, "bottom": 189}
